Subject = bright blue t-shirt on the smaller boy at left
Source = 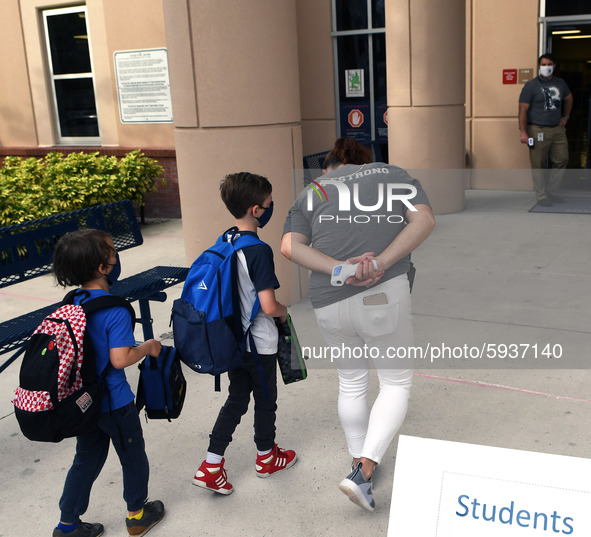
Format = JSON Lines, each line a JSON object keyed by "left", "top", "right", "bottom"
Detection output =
{"left": 74, "top": 289, "right": 135, "bottom": 412}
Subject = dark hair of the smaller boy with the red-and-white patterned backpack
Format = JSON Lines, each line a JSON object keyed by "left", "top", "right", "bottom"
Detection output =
{"left": 53, "top": 229, "right": 114, "bottom": 287}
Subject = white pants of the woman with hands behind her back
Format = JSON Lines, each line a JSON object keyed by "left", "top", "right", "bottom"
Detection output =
{"left": 314, "top": 274, "right": 414, "bottom": 464}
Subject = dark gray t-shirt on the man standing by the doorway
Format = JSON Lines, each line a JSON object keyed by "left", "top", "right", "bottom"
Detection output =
{"left": 519, "top": 76, "right": 570, "bottom": 127}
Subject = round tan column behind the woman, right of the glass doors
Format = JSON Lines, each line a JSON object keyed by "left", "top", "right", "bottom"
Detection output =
{"left": 386, "top": 0, "right": 466, "bottom": 214}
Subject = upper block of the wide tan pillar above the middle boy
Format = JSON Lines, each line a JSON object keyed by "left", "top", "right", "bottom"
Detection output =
{"left": 189, "top": 0, "right": 300, "bottom": 127}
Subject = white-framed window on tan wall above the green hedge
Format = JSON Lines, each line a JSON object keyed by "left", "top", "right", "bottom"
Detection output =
{"left": 43, "top": 6, "right": 100, "bottom": 144}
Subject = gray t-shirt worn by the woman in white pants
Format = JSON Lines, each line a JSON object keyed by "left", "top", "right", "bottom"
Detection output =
{"left": 283, "top": 162, "right": 429, "bottom": 308}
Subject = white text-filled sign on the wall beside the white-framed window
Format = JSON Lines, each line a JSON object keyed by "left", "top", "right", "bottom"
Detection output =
{"left": 113, "top": 48, "right": 172, "bottom": 123}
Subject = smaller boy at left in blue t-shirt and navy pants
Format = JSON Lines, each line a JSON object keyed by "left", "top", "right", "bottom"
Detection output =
{"left": 53, "top": 229, "right": 164, "bottom": 537}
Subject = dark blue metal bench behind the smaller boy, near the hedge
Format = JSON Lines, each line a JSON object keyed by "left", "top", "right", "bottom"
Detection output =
{"left": 0, "top": 200, "right": 189, "bottom": 372}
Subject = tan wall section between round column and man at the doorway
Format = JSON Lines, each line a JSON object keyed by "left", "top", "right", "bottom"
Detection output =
{"left": 468, "top": 0, "right": 539, "bottom": 190}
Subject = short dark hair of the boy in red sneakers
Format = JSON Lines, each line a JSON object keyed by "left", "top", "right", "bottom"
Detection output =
{"left": 220, "top": 172, "right": 273, "bottom": 218}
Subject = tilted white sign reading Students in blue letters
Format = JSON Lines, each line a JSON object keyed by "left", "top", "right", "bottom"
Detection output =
{"left": 388, "top": 436, "right": 591, "bottom": 537}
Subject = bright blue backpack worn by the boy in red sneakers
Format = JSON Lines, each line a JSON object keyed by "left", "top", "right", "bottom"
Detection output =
{"left": 172, "top": 227, "right": 264, "bottom": 391}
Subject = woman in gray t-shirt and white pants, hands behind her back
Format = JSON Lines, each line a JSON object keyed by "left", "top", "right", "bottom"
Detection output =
{"left": 281, "top": 138, "right": 435, "bottom": 511}
